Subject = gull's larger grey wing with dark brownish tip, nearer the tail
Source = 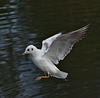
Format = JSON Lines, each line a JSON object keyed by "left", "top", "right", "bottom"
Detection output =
{"left": 44, "top": 25, "right": 89, "bottom": 64}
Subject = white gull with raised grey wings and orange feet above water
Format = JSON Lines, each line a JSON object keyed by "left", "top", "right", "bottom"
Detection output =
{"left": 22, "top": 25, "right": 89, "bottom": 81}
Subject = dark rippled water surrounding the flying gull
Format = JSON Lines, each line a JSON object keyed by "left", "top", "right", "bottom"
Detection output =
{"left": 0, "top": 0, "right": 100, "bottom": 98}
